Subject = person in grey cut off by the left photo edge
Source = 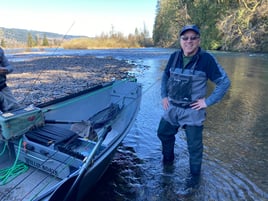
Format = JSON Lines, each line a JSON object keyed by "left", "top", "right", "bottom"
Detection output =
{"left": 0, "top": 47, "right": 19, "bottom": 113}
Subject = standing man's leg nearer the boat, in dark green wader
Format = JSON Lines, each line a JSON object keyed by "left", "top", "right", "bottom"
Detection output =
{"left": 157, "top": 118, "right": 178, "bottom": 164}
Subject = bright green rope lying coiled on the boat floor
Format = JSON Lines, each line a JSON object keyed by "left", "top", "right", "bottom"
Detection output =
{"left": 0, "top": 138, "right": 28, "bottom": 186}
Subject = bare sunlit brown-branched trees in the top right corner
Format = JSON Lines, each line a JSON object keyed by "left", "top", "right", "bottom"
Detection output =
{"left": 217, "top": 0, "right": 268, "bottom": 52}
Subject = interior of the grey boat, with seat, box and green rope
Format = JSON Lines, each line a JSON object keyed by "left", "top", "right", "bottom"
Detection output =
{"left": 0, "top": 80, "right": 140, "bottom": 200}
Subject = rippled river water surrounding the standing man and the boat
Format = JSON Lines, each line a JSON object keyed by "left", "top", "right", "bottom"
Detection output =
{"left": 6, "top": 48, "right": 268, "bottom": 201}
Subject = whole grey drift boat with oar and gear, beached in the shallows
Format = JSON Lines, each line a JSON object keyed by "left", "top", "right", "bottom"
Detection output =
{"left": 0, "top": 80, "right": 141, "bottom": 201}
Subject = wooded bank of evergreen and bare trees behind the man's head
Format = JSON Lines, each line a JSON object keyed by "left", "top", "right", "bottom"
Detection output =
{"left": 153, "top": 0, "right": 268, "bottom": 52}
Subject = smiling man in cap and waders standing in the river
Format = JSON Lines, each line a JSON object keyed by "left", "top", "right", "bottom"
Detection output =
{"left": 157, "top": 25, "right": 230, "bottom": 192}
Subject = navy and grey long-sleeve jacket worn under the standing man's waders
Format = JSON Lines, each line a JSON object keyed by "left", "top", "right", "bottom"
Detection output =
{"left": 161, "top": 48, "right": 231, "bottom": 106}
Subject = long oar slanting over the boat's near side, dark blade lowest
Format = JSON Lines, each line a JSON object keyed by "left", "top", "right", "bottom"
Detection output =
{"left": 49, "top": 125, "right": 112, "bottom": 201}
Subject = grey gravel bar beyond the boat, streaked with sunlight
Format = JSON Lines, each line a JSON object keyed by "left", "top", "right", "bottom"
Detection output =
{"left": 7, "top": 56, "right": 135, "bottom": 105}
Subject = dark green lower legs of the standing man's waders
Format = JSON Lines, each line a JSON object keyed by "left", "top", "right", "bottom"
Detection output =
{"left": 157, "top": 118, "right": 203, "bottom": 175}
